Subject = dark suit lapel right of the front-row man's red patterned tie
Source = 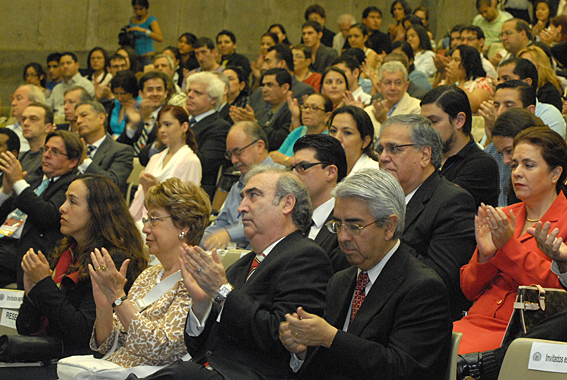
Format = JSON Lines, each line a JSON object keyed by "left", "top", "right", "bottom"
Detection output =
{"left": 343, "top": 245, "right": 409, "bottom": 336}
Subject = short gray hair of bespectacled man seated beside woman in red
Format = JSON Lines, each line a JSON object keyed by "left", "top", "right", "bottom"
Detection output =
{"left": 380, "top": 115, "right": 443, "bottom": 169}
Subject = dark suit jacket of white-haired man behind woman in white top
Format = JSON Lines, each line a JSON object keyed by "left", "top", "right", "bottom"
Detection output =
{"left": 192, "top": 112, "right": 230, "bottom": 200}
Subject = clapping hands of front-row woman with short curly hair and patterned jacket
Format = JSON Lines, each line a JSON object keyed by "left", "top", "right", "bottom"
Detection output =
{"left": 89, "top": 248, "right": 130, "bottom": 306}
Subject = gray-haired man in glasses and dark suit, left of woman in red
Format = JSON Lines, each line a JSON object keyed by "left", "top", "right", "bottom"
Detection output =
{"left": 376, "top": 115, "right": 476, "bottom": 320}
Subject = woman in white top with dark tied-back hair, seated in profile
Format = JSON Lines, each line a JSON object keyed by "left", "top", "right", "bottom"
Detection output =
{"left": 130, "top": 105, "right": 202, "bottom": 222}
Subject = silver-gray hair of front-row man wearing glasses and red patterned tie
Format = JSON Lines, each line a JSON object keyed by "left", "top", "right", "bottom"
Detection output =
{"left": 333, "top": 168, "right": 406, "bottom": 239}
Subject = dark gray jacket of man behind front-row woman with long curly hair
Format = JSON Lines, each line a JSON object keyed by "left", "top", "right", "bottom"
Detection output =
{"left": 85, "top": 134, "right": 135, "bottom": 194}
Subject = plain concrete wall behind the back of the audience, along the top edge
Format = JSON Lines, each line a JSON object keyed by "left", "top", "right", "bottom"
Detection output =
{"left": 0, "top": 0, "right": 476, "bottom": 105}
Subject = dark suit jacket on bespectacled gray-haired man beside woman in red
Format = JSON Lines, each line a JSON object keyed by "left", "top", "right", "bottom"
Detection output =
{"left": 402, "top": 171, "right": 476, "bottom": 320}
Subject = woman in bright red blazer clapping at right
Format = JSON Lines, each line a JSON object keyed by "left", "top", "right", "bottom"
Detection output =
{"left": 453, "top": 127, "right": 567, "bottom": 354}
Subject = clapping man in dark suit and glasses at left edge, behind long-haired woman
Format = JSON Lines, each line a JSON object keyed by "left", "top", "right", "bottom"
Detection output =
{"left": 0, "top": 130, "right": 83, "bottom": 289}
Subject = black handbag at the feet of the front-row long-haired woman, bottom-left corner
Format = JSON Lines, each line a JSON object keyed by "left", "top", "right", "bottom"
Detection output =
{"left": 0, "top": 335, "right": 63, "bottom": 362}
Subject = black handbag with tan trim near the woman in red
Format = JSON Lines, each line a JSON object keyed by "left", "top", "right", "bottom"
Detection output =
{"left": 502, "top": 285, "right": 567, "bottom": 345}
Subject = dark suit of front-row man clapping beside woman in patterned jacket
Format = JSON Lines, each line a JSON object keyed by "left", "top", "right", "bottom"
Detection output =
{"left": 185, "top": 231, "right": 332, "bottom": 380}
